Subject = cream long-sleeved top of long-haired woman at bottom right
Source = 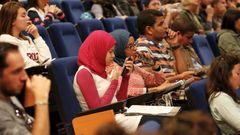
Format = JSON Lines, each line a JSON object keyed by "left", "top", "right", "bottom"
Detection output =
{"left": 210, "top": 92, "right": 240, "bottom": 135}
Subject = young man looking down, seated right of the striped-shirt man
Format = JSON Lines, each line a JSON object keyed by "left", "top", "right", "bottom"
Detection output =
{"left": 171, "top": 18, "right": 208, "bottom": 77}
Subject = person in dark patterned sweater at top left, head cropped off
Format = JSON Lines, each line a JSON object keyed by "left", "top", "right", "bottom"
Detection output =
{"left": 27, "top": 0, "right": 65, "bottom": 27}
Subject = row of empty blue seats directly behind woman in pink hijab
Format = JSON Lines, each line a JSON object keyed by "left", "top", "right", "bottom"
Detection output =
{"left": 37, "top": 17, "right": 138, "bottom": 58}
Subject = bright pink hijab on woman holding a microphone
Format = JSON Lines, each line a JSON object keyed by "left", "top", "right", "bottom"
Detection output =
{"left": 78, "top": 30, "right": 116, "bottom": 78}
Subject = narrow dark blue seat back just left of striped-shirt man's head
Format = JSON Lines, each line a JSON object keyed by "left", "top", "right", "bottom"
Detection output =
{"left": 125, "top": 16, "right": 139, "bottom": 40}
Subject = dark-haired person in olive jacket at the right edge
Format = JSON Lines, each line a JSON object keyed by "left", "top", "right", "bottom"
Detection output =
{"left": 217, "top": 9, "right": 240, "bottom": 54}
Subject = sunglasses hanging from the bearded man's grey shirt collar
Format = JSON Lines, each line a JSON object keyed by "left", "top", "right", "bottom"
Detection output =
{"left": 11, "top": 102, "right": 34, "bottom": 131}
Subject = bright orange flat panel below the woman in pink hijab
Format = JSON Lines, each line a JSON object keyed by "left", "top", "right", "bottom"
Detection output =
{"left": 72, "top": 110, "right": 115, "bottom": 135}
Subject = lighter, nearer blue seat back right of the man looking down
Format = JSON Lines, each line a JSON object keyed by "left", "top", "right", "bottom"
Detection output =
{"left": 192, "top": 35, "right": 214, "bottom": 65}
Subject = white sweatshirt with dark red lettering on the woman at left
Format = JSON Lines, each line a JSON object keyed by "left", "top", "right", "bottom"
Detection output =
{"left": 0, "top": 34, "right": 52, "bottom": 68}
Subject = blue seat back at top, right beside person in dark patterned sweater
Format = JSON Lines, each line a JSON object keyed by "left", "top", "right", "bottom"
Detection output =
{"left": 61, "top": 0, "right": 85, "bottom": 24}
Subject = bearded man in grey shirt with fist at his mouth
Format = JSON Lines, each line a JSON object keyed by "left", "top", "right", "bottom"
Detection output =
{"left": 0, "top": 43, "right": 50, "bottom": 135}
